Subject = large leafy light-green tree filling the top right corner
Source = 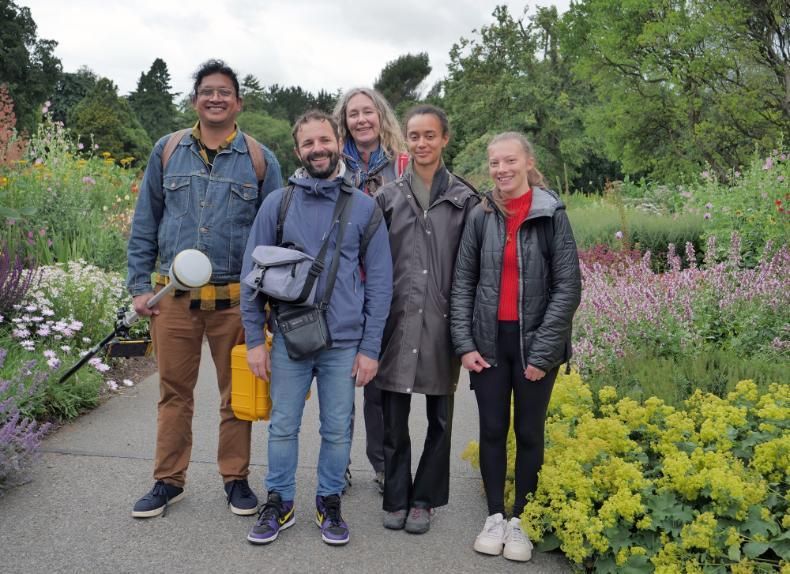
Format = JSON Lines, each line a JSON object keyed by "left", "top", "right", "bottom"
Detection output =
{"left": 563, "top": 0, "right": 790, "bottom": 179}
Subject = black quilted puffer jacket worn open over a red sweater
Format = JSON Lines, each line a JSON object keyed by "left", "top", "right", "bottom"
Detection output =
{"left": 450, "top": 187, "right": 581, "bottom": 372}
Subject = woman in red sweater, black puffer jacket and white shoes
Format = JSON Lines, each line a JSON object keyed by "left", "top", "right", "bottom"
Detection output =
{"left": 450, "top": 132, "right": 581, "bottom": 561}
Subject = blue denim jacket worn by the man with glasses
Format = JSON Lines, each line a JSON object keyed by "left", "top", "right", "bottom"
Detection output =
{"left": 127, "top": 130, "right": 282, "bottom": 296}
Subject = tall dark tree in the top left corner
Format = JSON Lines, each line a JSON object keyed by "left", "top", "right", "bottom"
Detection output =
{"left": 0, "top": 0, "right": 61, "bottom": 131}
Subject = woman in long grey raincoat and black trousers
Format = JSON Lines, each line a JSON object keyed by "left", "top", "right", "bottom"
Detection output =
{"left": 374, "top": 105, "right": 479, "bottom": 534}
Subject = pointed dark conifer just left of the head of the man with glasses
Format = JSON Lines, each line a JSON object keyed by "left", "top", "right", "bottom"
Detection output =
{"left": 129, "top": 58, "right": 177, "bottom": 141}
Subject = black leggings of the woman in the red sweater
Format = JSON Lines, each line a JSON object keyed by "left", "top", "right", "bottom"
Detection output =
{"left": 470, "top": 321, "right": 559, "bottom": 516}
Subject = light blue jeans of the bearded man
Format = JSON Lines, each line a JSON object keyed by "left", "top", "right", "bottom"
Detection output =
{"left": 266, "top": 333, "right": 357, "bottom": 500}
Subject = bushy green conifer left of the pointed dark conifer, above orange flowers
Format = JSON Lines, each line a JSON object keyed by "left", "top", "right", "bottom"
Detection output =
{"left": 70, "top": 78, "right": 152, "bottom": 166}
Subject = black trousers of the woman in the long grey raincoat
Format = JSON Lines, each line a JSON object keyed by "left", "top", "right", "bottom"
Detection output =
{"left": 381, "top": 391, "right": 453, "bottom": 512}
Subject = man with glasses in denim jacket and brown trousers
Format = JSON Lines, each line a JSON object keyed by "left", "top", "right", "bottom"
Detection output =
{"left": 127, "top": 60, "right": 282, "bottom": 518}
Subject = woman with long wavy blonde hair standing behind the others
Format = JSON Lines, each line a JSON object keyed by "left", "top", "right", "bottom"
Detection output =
{"left": 333, "top": 88, "right": 409, "bottom": 493}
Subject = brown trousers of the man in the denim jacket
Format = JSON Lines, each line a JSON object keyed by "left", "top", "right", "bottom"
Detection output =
{"left": 151, "top": 294, "right": 252, "bottom": 487}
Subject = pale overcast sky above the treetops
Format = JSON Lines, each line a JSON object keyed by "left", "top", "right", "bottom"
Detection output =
{"left": 17, "top": 0, "right": 569, "bottom": 99}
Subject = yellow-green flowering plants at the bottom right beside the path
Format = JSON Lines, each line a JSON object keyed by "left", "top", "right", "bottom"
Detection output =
{"left": 464, "top": 373, "right": 790, "bottom": 574}
